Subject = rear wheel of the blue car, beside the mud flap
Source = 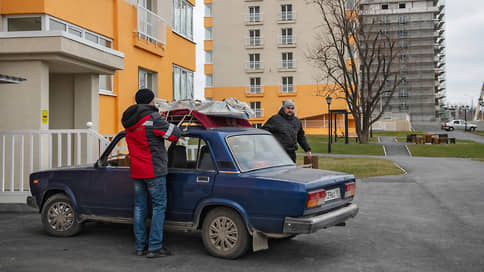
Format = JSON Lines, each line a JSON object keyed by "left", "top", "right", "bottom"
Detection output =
{"left": 202, "top": 208, "right": 250, "bottom": 259}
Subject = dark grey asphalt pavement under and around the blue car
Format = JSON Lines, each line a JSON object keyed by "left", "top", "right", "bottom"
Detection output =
{"left": 0, "top": 157, "right": 484, "bottom": 272}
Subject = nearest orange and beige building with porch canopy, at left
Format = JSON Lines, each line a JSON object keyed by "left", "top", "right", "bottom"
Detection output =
{"left": 0, "top": 0, "right": 195, "bottom": 134}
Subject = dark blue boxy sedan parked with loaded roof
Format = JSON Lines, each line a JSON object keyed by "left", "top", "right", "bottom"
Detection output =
{"left": 27, "top": 126, "right": 358, "bottom": 259}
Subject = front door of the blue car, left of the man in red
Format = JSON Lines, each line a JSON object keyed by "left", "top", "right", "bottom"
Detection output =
{"left": 87, "top": 135, "right": 134, "bottom": 218}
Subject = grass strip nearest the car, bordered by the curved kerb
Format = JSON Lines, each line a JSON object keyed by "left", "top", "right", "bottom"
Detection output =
{"left": 297, "top": 156, "right": 405, "bottom": 178}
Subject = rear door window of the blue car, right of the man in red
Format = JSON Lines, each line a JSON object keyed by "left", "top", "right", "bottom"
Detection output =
{"left": 168, "top": 137, "right": 215, "bottom": 171}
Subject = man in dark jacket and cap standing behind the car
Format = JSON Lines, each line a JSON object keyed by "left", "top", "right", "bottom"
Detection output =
{"left": 262, "top": 100, "right": 311, "bottom": 162}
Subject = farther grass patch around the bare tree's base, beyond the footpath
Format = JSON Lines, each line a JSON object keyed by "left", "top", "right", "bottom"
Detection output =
{"left": 304, "top": 135, "right": 385, "bottom": 156}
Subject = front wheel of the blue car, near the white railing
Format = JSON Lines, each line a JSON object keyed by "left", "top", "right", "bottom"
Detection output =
{"left": 41, "top": 194, "right": 82, "bottom": 237}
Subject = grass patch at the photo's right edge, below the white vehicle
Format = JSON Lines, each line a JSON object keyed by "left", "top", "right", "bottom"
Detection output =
{"left": 407, "top": 140, "right": 484, "bottom": 159}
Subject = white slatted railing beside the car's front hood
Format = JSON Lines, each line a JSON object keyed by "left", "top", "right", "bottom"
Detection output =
{"left": 0, "top": 125, "right": 109, "bottom": 192}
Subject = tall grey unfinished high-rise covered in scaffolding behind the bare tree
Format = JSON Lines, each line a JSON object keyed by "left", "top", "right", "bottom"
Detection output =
{"left": 360, "top": 0, "right": 445, "bottom": 121}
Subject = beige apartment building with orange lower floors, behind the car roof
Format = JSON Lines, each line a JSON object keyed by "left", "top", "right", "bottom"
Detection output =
{"left": 204, "top": 0, "right": 354, "bottom": 134}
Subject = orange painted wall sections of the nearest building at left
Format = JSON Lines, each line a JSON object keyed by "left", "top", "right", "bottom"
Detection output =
{"left": 0, "top": 0, "right": 195, "bottom": 134}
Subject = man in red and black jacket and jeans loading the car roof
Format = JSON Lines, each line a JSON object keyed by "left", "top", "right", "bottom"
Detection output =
{"left": 122, "top": 89, "right": 181, "bottom": 258}
